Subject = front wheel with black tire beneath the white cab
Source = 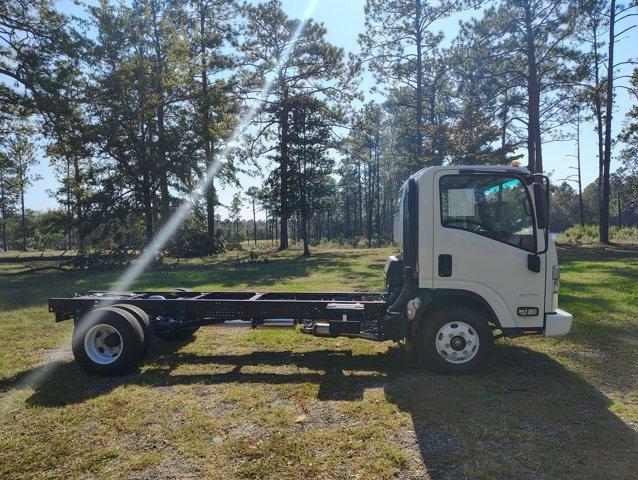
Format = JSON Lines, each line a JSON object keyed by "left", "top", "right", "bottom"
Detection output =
{"left": 416, "top": 305, "right": 494, "bottom": 374}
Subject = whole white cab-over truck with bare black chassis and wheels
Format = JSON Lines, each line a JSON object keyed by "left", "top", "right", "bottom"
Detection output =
{"left": 49, "top": 166, "right": 572, "bottom": 375}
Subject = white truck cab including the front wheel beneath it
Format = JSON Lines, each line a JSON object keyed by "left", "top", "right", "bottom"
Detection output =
{"left": 385, "top": 165, "right": 572, "bottom": 371}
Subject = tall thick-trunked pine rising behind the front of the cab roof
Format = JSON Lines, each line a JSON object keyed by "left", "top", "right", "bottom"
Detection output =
{"left": 461, "top": 0, "right": 580, "bottom": 173}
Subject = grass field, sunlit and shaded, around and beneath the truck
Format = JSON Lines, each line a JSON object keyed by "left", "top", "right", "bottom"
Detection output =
{"left": 0, "top": 246, "right": 638, "bottom": 479}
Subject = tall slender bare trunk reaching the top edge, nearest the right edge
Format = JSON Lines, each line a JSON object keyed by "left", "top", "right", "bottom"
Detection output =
{"left": 599, "top": 0, "right": 616, "bottom": 243}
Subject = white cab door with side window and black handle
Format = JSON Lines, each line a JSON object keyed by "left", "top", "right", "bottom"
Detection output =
{"left": 432, "top": 170, "right": 546, "bottom": 328}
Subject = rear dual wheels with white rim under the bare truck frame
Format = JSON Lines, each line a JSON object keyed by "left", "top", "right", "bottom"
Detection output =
{"left": 71, "top": 304, "right": 155, "bottom": 375}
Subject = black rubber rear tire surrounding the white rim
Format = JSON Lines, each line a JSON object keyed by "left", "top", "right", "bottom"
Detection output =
{"left": 71, "top": 307, "right": 144, "bottom": 376}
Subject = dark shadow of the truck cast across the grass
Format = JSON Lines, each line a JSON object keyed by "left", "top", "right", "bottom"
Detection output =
{"left": 0, "top": 344, "right": 638, "bottom": 479}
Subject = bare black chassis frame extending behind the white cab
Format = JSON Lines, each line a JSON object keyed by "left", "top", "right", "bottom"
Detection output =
{"left": 49, "top": 290, "right": 388, "bottom": 340}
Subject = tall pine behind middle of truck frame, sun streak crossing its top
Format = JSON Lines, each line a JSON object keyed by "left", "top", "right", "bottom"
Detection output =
{"left": 241, "top": 0, "right": 352, "bottom": 250}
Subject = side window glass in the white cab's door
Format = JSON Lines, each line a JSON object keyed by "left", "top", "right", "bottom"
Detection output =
{"left": 440, "top": 174, "right": 536, "bottom": 252}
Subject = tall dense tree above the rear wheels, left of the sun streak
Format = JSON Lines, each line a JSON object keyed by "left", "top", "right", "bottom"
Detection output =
{"left": 89, "top": 0, "right": 190, "bottom": 242}
